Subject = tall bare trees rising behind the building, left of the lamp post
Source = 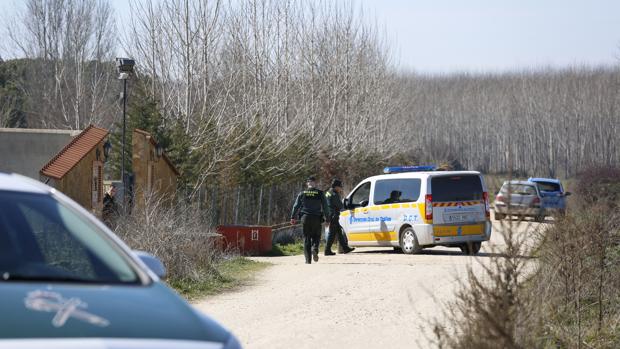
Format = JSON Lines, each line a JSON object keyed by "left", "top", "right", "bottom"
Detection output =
{"left": 7, "top": 0, "right": 116, "bottom": 129}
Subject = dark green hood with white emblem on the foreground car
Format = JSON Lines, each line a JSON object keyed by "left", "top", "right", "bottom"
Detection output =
{"left": 0, "top": 282, "right": 230, "bottom": 343}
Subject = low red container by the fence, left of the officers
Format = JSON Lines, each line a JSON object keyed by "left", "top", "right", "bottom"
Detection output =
{"left": 217, "top": 225, "right": 272, "bottom": 255}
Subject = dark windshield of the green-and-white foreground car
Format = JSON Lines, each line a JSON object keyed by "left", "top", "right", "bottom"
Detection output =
{"left": 0, "top": 191, "right": 139, "bottom": 284}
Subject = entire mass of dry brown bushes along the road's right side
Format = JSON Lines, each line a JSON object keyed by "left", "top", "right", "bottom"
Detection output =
{"left": 435, "top": 167, "right": 620, "bottom": 348}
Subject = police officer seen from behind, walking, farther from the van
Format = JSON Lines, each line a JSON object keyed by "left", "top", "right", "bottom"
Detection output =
{"left": 291, "top": 176, "right": 330, "bottom": 264}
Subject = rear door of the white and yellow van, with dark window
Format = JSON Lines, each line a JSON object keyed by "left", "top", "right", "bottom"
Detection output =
{"left": 431, "top": 174, "right": 486, "bottom": 227}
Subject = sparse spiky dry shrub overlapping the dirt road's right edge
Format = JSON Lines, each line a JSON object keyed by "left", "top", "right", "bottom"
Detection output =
{"left": 433, "top": 221, "right": 532, "bottom": 349}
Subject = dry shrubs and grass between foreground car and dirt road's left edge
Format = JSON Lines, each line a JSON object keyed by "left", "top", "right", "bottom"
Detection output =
{"left": 108, "top": 190, "right": 268, "bottom": 300}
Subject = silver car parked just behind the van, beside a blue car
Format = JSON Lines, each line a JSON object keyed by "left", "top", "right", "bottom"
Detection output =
{"left": 494, "top": 180, "right": 545, "bottom": 222}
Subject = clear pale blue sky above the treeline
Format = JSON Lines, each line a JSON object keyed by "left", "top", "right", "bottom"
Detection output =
{"left": 0, "top": 0, "right": 620, "bottom": 74}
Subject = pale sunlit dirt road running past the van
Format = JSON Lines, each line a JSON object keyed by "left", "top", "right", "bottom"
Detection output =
{"left": 195, "top": 223, "right": 537, "bottom": 349}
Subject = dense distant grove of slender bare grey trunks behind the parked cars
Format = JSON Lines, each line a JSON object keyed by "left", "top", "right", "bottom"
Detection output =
{"left": 397, "top": 67, "right": 620, "bottom": 177}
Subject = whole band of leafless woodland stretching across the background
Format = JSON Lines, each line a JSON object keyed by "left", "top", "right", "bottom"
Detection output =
{"left": 0, "top": 0, "right": 620, "bottom": 224}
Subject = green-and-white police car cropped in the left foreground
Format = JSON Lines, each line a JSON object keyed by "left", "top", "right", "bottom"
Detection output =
{"left": 0, "top": 173, "right": 240, "bottom": 349}
